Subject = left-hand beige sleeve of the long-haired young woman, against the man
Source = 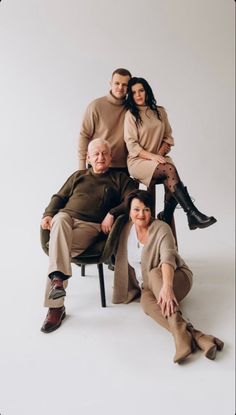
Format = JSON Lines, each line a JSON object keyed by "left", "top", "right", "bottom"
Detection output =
{"left": 124, "top": 111, "right": 143, "bottom": 157}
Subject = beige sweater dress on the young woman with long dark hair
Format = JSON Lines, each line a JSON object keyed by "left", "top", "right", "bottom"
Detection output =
{"left": 124, "top": 106, "right": 174, "bottom": 186}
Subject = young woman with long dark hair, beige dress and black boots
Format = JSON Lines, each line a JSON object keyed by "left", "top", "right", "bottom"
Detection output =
{"left": 124, "top": 77, "right": 216, "bottom": 229}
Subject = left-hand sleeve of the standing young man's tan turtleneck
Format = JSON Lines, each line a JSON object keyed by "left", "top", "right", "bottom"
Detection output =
{"left": 78, "top": 103, "right": 96, "bottom": 170}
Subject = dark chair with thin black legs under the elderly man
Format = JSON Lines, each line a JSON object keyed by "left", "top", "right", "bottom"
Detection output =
{"left": 40, "top": 215, "right": 128, "bottom": 307}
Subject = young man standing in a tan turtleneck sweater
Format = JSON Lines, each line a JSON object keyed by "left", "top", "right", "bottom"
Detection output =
{"left": 78, "top": 68, "right": 131, "bottom": 171}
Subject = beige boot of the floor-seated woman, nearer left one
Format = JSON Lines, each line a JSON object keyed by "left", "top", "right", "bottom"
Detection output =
{"left": 167, "top": 311, "right": 195, "bottom": 363}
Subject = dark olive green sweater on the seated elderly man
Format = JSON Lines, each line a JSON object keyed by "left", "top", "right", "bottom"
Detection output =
{"left": 43, "top": 168, "right": 137, "bottom": 223}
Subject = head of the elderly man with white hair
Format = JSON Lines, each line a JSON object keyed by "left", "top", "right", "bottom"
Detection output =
{"left": 88, "top": 144, "right": 111, "bottom": 173}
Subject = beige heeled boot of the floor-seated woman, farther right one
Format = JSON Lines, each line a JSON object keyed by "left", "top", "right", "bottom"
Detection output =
{"left": 187, "top": 323, "right": 224, "bottom": 360}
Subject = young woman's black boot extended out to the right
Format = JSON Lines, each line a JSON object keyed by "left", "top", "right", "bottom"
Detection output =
{"left": 173, "top": 182, "right": 216, "bottom": 229}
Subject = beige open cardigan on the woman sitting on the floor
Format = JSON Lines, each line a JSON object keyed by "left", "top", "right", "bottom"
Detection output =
{"left": 112, "top": 219, "right": 192, "bottom": 304}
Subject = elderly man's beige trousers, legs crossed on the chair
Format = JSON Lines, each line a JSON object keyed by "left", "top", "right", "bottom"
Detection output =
{"left": 44, "top": 212, "right": 101, "bottom": 308}
